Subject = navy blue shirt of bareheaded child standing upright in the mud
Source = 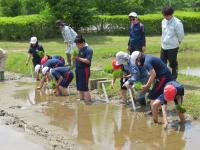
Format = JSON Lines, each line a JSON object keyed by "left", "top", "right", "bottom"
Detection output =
{"left": 76, "top": 46, "right": 93, "bottom": 68}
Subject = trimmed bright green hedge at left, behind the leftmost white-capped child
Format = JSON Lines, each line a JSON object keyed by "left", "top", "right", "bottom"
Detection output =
{"left": 0, "top": 15, "right": 56, "bottom": 40}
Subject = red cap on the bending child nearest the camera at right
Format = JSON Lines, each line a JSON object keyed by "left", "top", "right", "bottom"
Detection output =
{"left": 164, "top": 84, "right": 176, "bottom": 101}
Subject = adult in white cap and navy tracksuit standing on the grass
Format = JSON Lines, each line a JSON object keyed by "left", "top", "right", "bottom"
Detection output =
{"left": 128, "top": 12, "right": 146, "bottom": 54}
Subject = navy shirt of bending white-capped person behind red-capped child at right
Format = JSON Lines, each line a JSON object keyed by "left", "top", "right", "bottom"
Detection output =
{"left": 144, "top": 55, "right": 171, "bottom": 79}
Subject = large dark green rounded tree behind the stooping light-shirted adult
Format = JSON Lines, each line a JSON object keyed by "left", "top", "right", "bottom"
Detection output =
{"left": 47, "top": 0, "right": 94, "bottom": 30}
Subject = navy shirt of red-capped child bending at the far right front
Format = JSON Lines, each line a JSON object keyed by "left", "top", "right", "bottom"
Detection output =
{"left": 158, "top": 81, "right": 184, "bottom": 105}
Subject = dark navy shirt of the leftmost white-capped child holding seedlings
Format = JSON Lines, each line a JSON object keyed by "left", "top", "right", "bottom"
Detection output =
{"left": 28, "top": 44, "right": 44, "bottom": 61}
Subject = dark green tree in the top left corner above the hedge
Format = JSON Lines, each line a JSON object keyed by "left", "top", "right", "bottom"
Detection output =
{"left": 0, "top": 0, "right": 22, "bottom": 17}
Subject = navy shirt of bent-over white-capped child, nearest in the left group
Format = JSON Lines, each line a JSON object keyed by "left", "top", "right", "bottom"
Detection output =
{"left": 52, "top": 67, "right": 72, "bottom": 80}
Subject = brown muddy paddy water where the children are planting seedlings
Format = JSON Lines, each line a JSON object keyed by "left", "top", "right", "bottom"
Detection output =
{"left": 0, "top": 80, "right": 200, "bottom": 150}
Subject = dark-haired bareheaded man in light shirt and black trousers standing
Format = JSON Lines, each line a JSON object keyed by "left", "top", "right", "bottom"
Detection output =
{"left": 160, "top": 7, "right": 184, "bottom": 80}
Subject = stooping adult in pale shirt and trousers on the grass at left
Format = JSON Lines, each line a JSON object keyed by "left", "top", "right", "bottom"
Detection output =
{"left": 56, "top": 20, "right": 77, "bottom": 66}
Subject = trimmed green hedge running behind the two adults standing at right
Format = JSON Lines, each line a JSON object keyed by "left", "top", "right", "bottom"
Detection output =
{"left": 87, "top": 11, "right": 200, "bottom": 35}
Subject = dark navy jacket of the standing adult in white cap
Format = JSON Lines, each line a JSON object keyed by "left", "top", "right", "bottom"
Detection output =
{"left": 128, "top": 22, "right": 146, "bottom": 50}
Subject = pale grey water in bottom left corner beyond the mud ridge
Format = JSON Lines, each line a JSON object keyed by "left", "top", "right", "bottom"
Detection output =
{"left": 0, "top": 121, "right": 44, "bottom": 150}
